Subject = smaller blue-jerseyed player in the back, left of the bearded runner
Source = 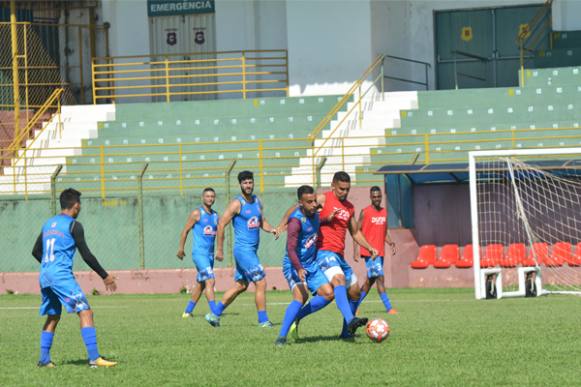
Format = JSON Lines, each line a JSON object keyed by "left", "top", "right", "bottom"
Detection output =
{"left": 177, "top": 188, "right": 218, "bottom": 318}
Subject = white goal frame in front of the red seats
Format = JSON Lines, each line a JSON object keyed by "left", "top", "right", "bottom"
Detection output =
{"left": 468, "top": 147, "right": 581, "bottom": 300}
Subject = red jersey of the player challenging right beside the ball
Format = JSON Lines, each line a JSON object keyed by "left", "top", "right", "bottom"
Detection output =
{"left": 317, "top": 191, "right": 355, "bottom": 255}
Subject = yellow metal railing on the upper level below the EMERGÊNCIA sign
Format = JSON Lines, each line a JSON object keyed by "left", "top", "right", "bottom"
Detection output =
{"left": 92, "top": 50, "right": 289, "bottom": 103}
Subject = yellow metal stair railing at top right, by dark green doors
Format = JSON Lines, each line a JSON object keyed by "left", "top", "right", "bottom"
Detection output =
{"left": 516, "top": 0, "right": 553, "bottom": 87}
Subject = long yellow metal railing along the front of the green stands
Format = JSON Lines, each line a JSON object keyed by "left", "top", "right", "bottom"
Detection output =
{"left": 0, "top": 123, "right": 581, "bottom": 198}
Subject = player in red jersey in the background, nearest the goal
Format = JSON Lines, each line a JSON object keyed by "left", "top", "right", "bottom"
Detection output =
{"left": 353, "top": 186, "right": 397, "bottom": 314}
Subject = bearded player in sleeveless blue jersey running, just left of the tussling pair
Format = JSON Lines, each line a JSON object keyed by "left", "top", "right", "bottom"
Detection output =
{"left": 206, "top": 171, "right": 278, "bottom": 328}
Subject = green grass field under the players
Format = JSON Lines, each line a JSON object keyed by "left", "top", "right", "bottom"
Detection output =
{"left": 0, "top": 289, "right": 581, "bottom": 386}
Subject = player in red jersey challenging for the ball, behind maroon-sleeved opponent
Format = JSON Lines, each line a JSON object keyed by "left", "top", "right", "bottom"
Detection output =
{"left": 279, "top": 171, "right": 377, "bottom": 338}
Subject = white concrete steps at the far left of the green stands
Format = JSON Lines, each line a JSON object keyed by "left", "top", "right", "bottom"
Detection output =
{"left": 0, "top": 105, "right": 115, "bottom": 194}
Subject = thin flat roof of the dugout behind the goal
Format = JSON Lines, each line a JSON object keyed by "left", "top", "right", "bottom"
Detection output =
{"left": 375, "top": 159, "right": 581, "bottom": 184}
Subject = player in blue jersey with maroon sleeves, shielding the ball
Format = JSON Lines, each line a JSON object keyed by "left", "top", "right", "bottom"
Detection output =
{"left": 275, "top": 185, "right": 333, "bottom": 347}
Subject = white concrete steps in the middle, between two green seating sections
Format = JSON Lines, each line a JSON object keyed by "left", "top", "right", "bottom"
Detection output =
{"left": 285, "top": 92, "right": 418, "bottom": 187}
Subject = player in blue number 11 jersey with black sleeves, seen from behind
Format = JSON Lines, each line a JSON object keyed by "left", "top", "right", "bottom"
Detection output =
{"left": 32, "top": 188, "right": 117, "bottom": 368}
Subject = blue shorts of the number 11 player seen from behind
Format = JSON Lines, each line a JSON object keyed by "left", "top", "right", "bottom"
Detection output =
{"left": 40, "top": 278, "right": 91, "bottom": 316}
